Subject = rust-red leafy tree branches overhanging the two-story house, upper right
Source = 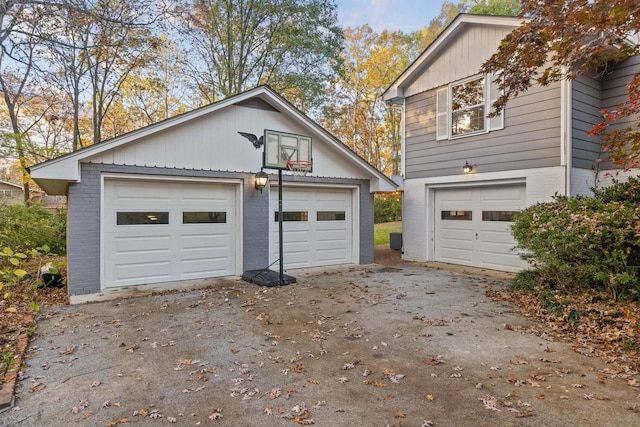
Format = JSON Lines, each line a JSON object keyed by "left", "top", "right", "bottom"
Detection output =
{"left": 481, "top": 0, "right": 640, "bottom": 168}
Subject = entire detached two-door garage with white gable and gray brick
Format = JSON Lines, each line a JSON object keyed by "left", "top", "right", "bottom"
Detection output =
{"left": 31, "top": 87, "right": 396, "bottom": 300}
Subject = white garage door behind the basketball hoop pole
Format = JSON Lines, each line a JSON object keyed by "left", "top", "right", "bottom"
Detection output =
{"left": 269, "top": 186, "right": 354, "bottom": 268}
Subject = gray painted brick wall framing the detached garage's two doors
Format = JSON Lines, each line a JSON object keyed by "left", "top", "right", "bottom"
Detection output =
{"left": 67, "top": 163, "right": 374, "bottom": 296}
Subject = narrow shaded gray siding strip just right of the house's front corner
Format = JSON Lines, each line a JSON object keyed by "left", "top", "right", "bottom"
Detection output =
{"left": 571, "top": 75, "right": 602, "bottom": 169}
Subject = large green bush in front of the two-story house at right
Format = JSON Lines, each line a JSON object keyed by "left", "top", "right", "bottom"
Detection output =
{"left": 512, "top": 179, "right": 640, "bottom": 300}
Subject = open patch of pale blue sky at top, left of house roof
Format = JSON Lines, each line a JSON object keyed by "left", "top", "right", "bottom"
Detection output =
{"left": 336, "top": 0, "right": 442, "bottom": 33}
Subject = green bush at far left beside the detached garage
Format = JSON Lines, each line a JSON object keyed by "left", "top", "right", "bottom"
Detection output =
{"left": 0, "top": 205, "right": 67, "bottom": 260}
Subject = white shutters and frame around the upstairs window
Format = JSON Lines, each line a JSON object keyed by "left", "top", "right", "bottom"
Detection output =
{"left": 436, "top": 75, "right": 504, "bottom": 141}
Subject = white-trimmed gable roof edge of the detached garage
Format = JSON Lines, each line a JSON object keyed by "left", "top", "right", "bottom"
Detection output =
{"left": 30, "top": 86, "right": 397, "bottom": 194}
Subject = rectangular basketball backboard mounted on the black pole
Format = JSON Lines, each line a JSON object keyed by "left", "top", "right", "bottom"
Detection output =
{"left": 264, "top": 129, "right": 311, "bottom": 170}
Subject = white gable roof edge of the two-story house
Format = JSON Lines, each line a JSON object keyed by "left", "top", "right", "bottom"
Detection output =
{"left": 382, "top": 13, "right": 522, "bottom": 102}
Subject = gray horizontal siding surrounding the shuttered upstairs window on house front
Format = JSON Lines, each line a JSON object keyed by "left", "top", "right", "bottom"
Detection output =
{"left": 405, "top": 84, "right": 561, "bottom": 179}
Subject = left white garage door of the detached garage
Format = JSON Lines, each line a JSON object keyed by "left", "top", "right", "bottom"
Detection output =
{"left": 103, "top": 180, "right": 237, "bottom": 287}
